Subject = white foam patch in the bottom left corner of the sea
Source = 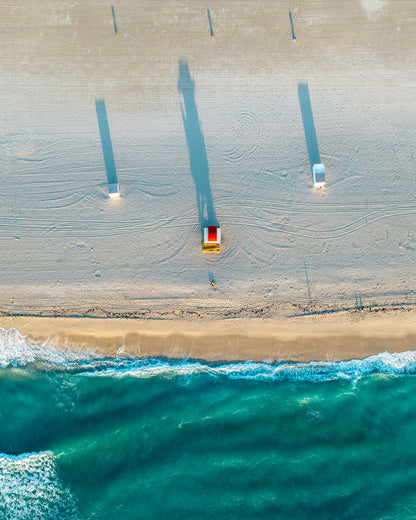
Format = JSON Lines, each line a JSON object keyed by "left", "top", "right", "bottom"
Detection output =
{"left": 0, "top": 452, "right": 81, "bottom": 520}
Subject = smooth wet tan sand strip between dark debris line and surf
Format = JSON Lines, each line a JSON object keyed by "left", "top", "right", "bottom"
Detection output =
{"left": 0, "top": 309, "right": 416, "bottom": 362}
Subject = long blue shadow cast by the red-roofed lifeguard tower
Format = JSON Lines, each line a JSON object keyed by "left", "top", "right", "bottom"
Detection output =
{"left": 178, "top": 60, "right": 218, "bottom": 228}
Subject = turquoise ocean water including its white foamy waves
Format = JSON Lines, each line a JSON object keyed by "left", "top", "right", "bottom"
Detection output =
{"left": 0, "top": 329, "right": 416, "bottom": 520}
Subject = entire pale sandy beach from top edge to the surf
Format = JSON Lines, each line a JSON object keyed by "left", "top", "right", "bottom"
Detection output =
{"left": 0, "top": 0, "right": 416, "bottom": 360}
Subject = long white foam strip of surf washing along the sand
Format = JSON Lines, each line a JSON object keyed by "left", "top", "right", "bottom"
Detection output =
{"left": 0, "top": 328, "right": 416, "bottom": 382}
